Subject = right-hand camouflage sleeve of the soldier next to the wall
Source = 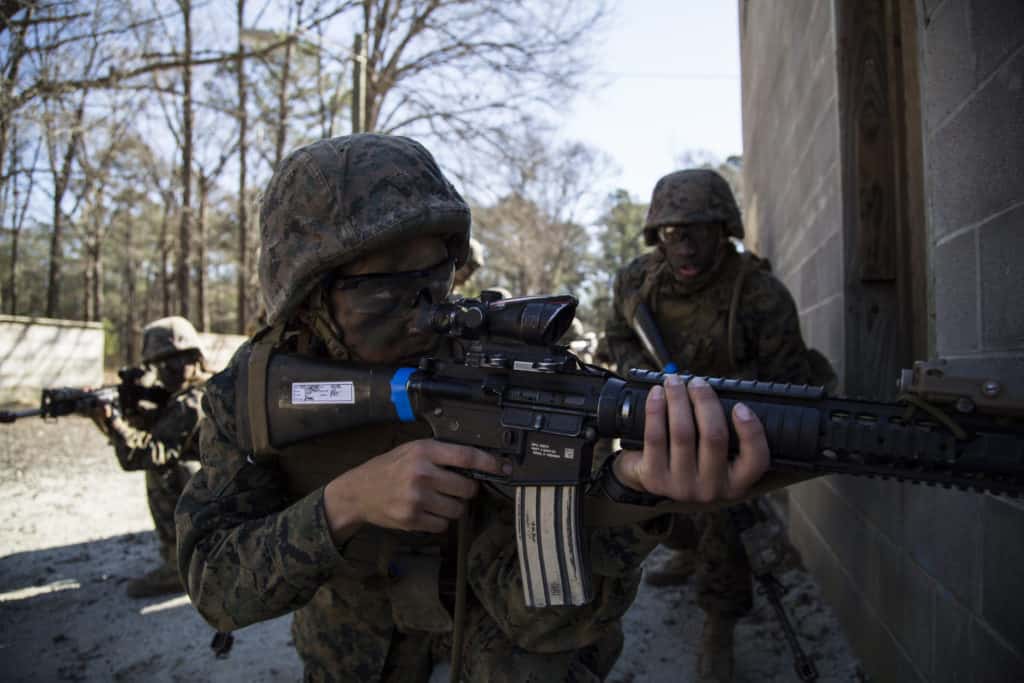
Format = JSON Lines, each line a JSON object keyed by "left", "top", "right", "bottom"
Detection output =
{"left": 739, "top": 270, "right": 811, "bottom": 384}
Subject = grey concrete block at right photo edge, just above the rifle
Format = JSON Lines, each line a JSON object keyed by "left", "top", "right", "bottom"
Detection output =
{"left": 978, "top": 204, "right": 1024, "bottom": 348}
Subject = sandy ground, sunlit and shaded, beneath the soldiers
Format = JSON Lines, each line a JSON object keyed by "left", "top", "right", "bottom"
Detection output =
{"left": 0, "top": 418, "right": 864, "bottom": 683}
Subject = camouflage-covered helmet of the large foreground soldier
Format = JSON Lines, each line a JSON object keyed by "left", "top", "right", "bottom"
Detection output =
{"left": 259, "top": 133, "right": 470, "bottom": 325}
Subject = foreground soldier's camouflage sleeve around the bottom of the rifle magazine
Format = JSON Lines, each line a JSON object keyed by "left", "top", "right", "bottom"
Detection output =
{"left": 468, "top": 489, "right": 672, "bottom": 652}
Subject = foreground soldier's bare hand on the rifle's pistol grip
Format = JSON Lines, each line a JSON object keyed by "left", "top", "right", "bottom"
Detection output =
{"left": 324, "top": 439, "right": 502, "bottom": 543}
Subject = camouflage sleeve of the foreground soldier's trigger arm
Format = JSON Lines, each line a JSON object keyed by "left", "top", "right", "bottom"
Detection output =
{"left": 175, "top": 356, "right": 344, "bottom": 631}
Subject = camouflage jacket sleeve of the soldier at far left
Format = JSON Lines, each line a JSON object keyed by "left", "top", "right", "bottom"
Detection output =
{"left": 105, "top": 387, "right": 203, "bottom": 470}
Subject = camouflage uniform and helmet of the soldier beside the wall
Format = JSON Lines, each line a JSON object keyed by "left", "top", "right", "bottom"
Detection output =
{"left": 605, "top": 170, "right": 826, "bottom": 620}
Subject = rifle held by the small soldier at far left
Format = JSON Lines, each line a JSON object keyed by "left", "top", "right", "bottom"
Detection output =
{"left": 0, "top": 368, "right": 170, "bottom": 424}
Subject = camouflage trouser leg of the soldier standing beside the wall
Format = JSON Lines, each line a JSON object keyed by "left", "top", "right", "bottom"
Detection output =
{"left": 665, "top": 503, "right": 754, "bottom": 618}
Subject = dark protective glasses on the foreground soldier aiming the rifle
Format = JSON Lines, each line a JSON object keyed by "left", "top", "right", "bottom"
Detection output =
{"left": 331, "top": 259, "right": 455, "bottom": 315}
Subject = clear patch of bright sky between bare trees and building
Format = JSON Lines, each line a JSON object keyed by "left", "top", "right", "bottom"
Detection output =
{"left": 561, "top": 0, "right": 742, "bottom": 201}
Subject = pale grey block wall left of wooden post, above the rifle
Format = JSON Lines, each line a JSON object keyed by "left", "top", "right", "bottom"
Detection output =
{"left": 739, "top": 2, "right": 844, "bottom": 377}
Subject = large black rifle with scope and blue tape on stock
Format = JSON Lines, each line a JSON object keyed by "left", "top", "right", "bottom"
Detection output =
{"left": 236, "top": 292, "right": 1024, "bottom": 607}
